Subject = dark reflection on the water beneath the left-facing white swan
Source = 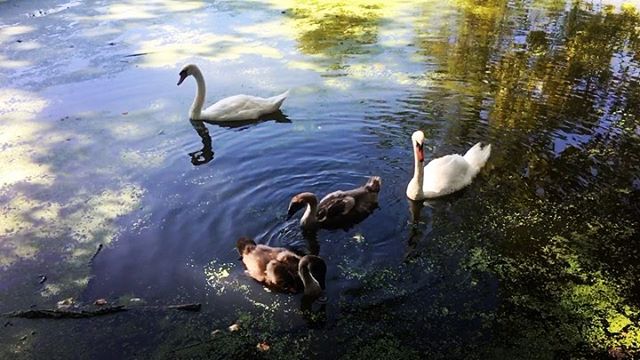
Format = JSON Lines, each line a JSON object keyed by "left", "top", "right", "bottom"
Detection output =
{"left": 188, "top": 110, "right": 291, "bottom": 166}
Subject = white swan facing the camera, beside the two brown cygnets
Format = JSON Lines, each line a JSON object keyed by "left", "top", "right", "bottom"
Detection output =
{"left": 407, "top": 131, "right": 491, "bottom": 200}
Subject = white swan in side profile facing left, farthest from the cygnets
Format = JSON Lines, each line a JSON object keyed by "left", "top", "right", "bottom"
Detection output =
{"left": 178, "top": 64, "right": 289, "bottom": 121}
